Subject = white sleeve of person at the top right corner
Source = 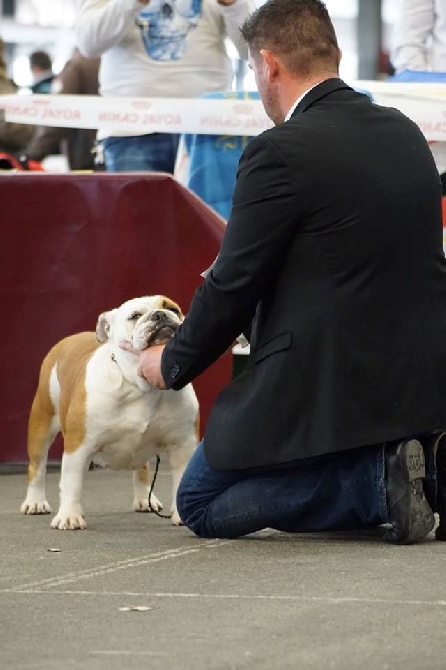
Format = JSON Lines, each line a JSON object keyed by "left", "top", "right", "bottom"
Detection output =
{"left": 391, "top": 0, "right": 435, "bottom": 72}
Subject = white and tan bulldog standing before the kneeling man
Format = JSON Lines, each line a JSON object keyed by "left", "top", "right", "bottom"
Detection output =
{"left": 21, "top": 295, "right": 199, "bottom": 530}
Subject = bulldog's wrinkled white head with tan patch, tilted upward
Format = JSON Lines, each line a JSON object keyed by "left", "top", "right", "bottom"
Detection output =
{"left": 96, "top": 295, "right": 184, "bottom": 350}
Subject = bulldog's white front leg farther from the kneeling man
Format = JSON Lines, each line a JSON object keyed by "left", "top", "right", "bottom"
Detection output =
{"left": 51, "top": 446, "right": 92, "bottom": 530}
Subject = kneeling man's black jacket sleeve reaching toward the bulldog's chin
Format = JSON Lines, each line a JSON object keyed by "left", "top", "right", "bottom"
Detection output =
{"left": 161, "top": 136, "right": 301, "bottom": 390}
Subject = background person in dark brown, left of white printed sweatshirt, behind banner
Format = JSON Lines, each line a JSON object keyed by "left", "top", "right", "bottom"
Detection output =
{"left": 21, "top": 48, "right": 100, "bottom": 170}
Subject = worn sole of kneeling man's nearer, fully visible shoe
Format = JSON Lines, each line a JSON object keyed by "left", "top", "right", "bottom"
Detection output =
{"left": 384, "top": 440, "right": 435, "bottom": 544}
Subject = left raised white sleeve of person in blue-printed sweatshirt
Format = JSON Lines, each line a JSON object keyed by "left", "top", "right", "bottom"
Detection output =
{"left": 75, "top": 0, "right": 144, "bottom": 58}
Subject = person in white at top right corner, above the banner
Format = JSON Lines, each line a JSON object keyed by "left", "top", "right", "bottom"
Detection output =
{"left": 392, "top": 0, "right": 446, "bottom": 72}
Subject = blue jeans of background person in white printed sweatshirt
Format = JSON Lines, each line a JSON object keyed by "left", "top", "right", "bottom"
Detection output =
{"left": 102, "top": 133, "right": 180, "bottom": 174}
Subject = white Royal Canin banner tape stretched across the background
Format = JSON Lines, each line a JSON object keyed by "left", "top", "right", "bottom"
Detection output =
{"left": 0, "top": 81, "right": 446, "bottom": 142}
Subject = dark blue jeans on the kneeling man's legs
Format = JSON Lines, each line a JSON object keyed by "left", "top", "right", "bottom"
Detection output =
{"left": 177, "top": 442, "right": 388, "bottom": 538}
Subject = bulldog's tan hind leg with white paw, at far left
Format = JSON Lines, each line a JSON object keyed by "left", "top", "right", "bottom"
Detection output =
{"left": 20, "top": 379, "right": 60, "bottom": 514}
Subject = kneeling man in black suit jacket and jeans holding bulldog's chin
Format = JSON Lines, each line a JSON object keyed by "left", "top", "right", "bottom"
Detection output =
{"left": 121, "top": 0, "right": 446, "bottom": 544}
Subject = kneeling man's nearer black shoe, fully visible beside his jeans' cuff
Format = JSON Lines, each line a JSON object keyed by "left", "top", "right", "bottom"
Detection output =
{"left": 384, "top": 440, "right": 434, "bottom": 544}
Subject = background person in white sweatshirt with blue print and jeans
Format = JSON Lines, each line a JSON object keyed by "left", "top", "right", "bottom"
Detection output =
{"left": 76, "top": 0, "right": 255, "bottom": 174}
